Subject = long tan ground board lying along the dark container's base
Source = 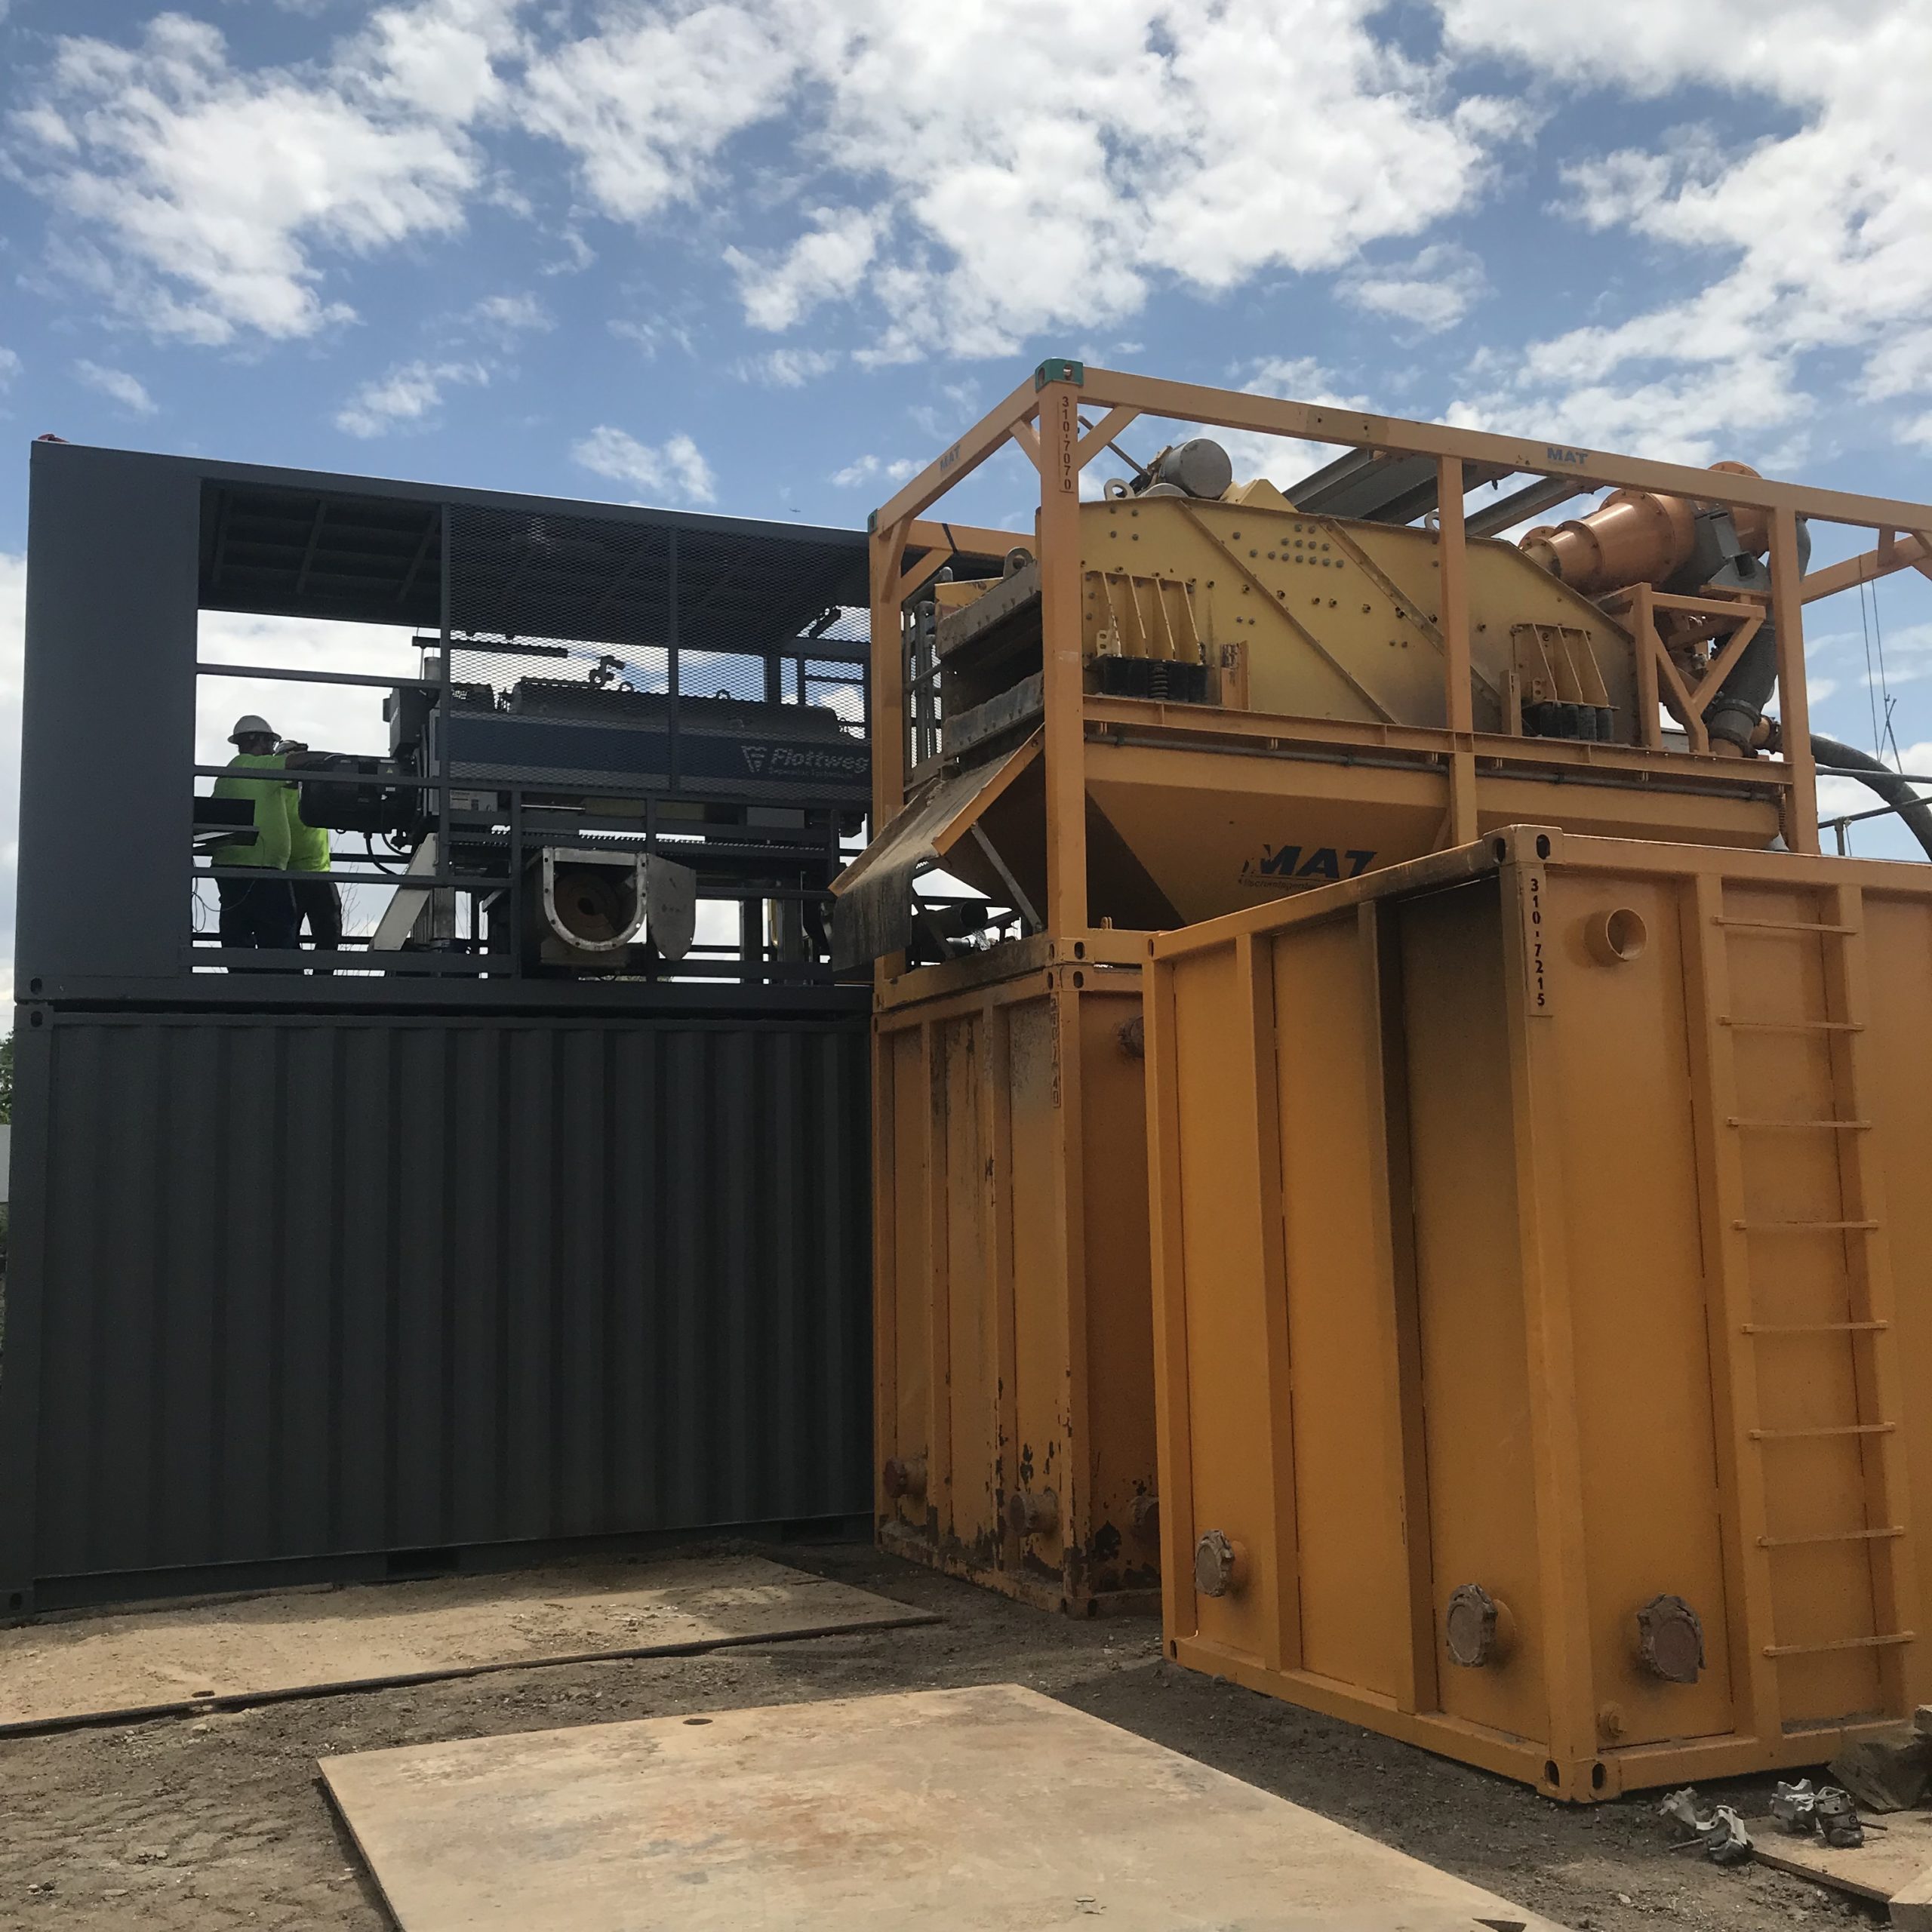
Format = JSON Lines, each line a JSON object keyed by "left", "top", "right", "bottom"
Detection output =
{"left": 0, "top": 1557, "right": 935, "bottom": 1735}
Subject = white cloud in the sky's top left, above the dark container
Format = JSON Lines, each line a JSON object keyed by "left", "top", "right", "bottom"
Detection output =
{"left": 14, "top": 0, "right": 518, "bottom": 344}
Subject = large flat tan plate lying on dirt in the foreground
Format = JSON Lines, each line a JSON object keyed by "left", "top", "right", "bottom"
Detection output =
{"left": 321, "top": 1684, "right": 1555, "bottom": 1932}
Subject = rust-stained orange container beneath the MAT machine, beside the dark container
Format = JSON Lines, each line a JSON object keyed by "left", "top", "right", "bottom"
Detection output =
{"left": 873, "top": 935, "right": 1157, "bottom": 1614}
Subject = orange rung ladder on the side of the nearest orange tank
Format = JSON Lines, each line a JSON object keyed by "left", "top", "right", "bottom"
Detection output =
{"left": 1698, "top": 879, "right": 1917, "bottom": 1725}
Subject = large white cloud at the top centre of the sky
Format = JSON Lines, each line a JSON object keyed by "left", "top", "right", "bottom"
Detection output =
{"left": 524, "top": 0, "right": 1528, "bottom": 361}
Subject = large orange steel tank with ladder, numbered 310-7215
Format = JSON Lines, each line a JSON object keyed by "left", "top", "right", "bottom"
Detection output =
{"left": 1148, "top": 829, "right": 1932, "bottom": 1798}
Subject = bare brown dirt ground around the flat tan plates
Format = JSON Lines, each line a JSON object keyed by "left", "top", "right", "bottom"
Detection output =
{"left": 0, "top": 1543, "right": 1884, "bottom": 1932}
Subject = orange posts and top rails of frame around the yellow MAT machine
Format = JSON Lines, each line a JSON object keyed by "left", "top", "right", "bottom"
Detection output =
{"left": 869, "top": 361, "right": 1932, "bottom": 935}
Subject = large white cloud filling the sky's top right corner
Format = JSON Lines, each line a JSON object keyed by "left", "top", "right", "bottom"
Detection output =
{"left": 1441, "top": 0, "right": 1932, "bottom": 460}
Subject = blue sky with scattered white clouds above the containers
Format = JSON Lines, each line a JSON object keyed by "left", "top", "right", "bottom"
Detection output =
{"left": 0, "top": 0, "right": 1932, "bottom": 989}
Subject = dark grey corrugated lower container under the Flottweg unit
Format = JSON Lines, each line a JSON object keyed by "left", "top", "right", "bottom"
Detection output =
{"left": 0, "top": 1008, "right": 872, "bottom": 1607}
